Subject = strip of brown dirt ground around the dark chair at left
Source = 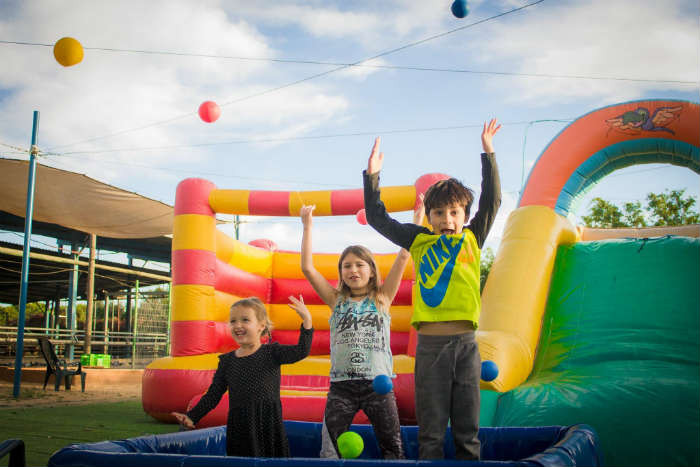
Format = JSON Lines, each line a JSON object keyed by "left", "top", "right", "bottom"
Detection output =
{"left": 0, "top": 378, "right": 141, "bottom": 409}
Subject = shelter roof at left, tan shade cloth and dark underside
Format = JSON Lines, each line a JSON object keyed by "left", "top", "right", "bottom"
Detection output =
{"left": 0, "top": 159, "right": 174, "bottom": 303}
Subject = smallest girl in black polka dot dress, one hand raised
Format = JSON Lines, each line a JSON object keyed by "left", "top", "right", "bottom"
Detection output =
{"left": 172, "top": 296, "right": 313, "bottom": 457}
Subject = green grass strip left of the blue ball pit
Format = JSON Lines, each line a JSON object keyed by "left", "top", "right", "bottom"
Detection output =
{"left": 0, "top": 400, "right": 178, "bottom": 466}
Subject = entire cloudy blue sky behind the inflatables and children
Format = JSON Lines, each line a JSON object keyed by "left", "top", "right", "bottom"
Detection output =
{"left": 0, "top": 0, "right": 700, "bottom": 260}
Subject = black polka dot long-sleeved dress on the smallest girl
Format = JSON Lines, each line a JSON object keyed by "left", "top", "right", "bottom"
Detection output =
{"left": 187, "top": 326, "right": 313, "bottom": 457}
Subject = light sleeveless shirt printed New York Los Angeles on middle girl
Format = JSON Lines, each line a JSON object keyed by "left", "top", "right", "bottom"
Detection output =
{"left": 330, "top": 297, "right": 393, "bottom": 382}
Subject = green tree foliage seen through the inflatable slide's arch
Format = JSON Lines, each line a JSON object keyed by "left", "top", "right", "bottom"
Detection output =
{"left": 582, "top": 189, "right": 700, "bottom": 229}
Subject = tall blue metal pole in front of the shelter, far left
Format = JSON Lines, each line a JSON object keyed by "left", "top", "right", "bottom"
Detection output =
{"left": 12, "top": 110, "right": 39, "bottom": 398}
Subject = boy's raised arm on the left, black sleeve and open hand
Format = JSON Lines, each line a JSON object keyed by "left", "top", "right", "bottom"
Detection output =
{"left": 364, "top": 138, "right": 430, "bottom": 250}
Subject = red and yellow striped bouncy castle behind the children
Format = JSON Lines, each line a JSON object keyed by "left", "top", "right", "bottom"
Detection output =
{"left": 143, "top": 174, "right": 446, "bottom": 426}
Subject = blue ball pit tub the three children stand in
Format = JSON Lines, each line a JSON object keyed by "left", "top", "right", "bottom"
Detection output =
{"left": 48, "top": 421, "right": 602, "bottom": 467}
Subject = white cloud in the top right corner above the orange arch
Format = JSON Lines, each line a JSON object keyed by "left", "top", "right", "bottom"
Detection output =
{"left": 474, "top": 0, "right": 698, "bottom": 105}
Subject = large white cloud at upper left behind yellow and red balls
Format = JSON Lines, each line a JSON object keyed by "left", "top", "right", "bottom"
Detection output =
{"left": 0, "top": 0, "right": 348, "bottom": 194}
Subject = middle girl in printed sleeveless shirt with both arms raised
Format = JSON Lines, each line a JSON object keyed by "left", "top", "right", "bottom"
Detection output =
{"left": 301, "top": 206, "right": 422, "bottom": 459}
